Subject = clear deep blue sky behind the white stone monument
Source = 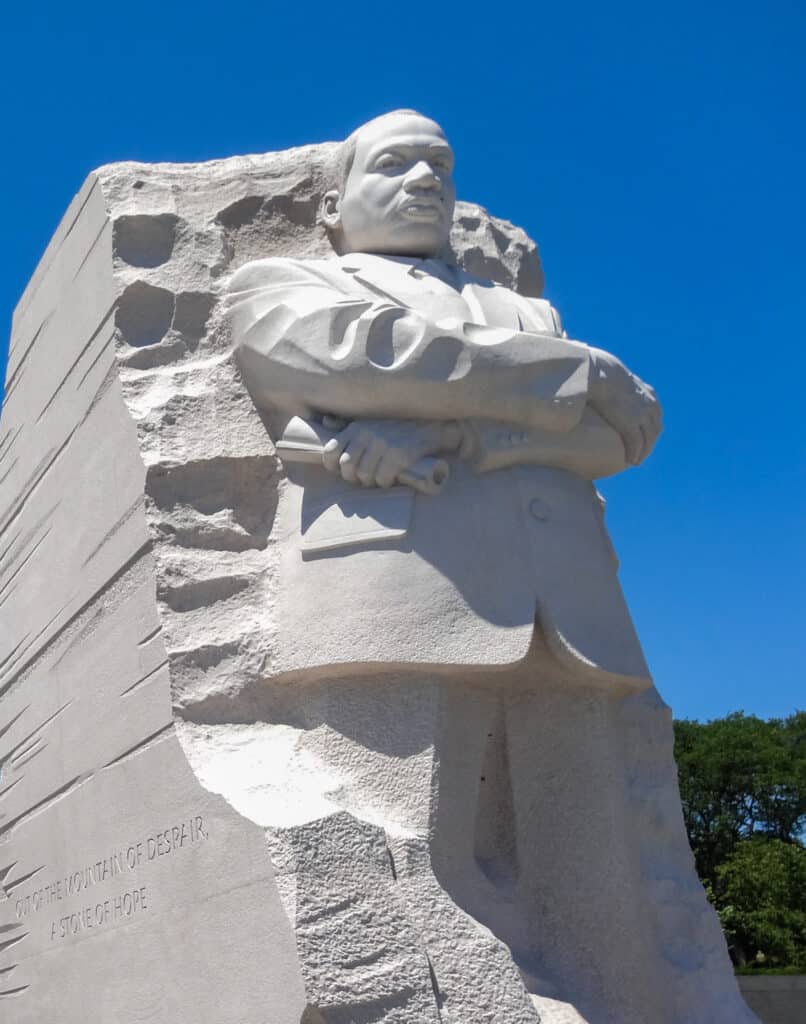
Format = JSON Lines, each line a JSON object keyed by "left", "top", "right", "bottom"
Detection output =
{"left": 0, "top": 0, "right": 806, "bottom": 718}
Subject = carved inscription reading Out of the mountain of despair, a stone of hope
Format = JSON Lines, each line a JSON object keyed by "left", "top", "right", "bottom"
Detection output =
{"left": 14, "top": 814, "right": 209, "bottom": 941}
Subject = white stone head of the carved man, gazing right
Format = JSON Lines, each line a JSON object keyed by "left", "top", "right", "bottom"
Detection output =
{"left": 322, "top": 111, "right": 456, "bottom": 257}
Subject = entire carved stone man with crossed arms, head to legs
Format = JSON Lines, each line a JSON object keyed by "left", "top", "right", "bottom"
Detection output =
{"left": 227, "top": 111, "right": 753, "bottom": 1024}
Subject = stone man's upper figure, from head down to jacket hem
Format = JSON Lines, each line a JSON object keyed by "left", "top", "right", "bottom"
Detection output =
{"left": 229, "top": 112, "right": 661, "bottom": 688}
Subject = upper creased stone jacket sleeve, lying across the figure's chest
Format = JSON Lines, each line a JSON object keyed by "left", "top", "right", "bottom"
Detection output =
{"left": 227, "top": 259, "right": 590, "bottom": 432}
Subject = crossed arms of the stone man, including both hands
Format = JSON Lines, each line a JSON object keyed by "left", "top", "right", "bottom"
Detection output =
{"left": 228, "top": 253, "right": 660, "bottom": 485}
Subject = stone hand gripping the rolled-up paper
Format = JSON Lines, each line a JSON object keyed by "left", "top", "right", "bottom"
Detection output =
{"left": 322, "top": 420, "right": 463, "bottom": 487}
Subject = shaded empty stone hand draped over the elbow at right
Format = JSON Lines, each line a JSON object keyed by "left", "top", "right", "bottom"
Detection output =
{"left": 590, "top": 348, "right": 662, "bottom": 466}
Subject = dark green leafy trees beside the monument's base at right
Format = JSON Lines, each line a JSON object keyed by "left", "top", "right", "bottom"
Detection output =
{"left": 675, "top": 712, "right": 806, "bottom": 970}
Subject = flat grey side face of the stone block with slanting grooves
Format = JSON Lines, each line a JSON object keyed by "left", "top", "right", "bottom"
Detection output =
{"left": 0, "top": 169, "right": 304, "bottom": 1024}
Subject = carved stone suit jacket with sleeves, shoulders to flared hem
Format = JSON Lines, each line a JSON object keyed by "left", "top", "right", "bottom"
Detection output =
{"left": 228, "top": 254, "right": 649, "bottom": 688}
